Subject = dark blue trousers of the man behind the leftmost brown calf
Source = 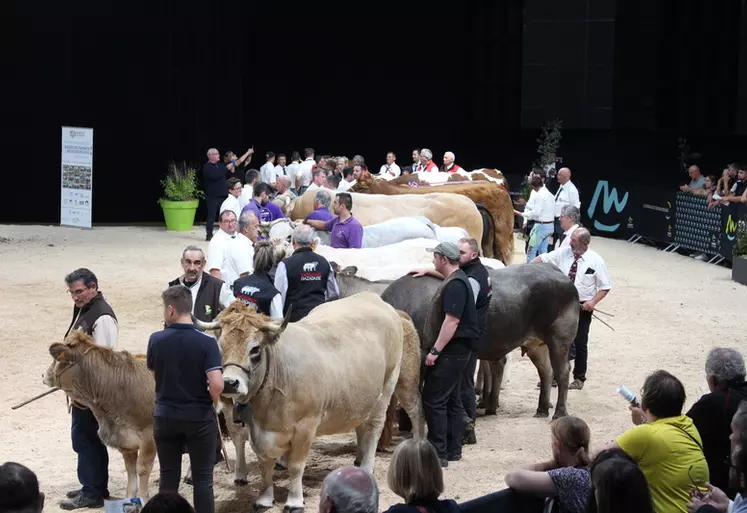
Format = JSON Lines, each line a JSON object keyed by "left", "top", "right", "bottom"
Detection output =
{"left": 71, "top": 406, "right": 109, "bottom": 499}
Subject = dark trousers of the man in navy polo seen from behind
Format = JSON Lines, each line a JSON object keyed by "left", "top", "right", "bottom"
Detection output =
{"left": 153, "top": 417, "right": 218, "bottom": 513}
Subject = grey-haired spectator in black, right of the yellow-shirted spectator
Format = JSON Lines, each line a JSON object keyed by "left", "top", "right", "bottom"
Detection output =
{"left": 687, "top": 347, "right": 747, "bottom": 497}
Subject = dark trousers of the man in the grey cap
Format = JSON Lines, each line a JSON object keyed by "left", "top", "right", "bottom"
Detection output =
{"left": 423, "top": 353, "right": 470, "bottom": 459}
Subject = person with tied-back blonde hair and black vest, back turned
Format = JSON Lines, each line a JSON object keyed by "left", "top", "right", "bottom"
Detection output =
{"left": 233, "top": 240, "right": 283, "bottom": 319}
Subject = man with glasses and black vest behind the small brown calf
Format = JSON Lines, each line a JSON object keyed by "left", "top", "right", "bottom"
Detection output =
{"left": 60, "top": 269, "right": 118, "bottom": 510}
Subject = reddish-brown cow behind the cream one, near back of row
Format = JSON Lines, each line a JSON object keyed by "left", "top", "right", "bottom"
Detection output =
{"left": 351, "top": 172, "right": 514, "bottom": 265}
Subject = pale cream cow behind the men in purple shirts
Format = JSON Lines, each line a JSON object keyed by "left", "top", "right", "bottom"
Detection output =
{"left": 291, "top": 187, "right": 482, "bottom": 247}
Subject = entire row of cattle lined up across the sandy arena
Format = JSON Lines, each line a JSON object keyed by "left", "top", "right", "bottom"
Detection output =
{"left": 38, "top": 170, "right": 579, "bottom": 510}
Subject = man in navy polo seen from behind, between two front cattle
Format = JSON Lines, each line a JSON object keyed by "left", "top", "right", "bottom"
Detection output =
{"left": 147, "top": 285, "right": 223, "bottom": 513}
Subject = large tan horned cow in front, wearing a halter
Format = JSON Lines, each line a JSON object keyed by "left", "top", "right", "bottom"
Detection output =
{"left": 196, "top": 298, "right": 425, "bottom": 511}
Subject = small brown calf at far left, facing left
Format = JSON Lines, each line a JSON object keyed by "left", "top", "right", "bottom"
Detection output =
{"left": 43, "top": 330, "right": 156, "bottom": 498}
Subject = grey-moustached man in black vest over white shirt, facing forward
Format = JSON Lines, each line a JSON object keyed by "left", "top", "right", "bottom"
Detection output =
{"left": 169, "top": 246, "right": 235, "bottom": 322}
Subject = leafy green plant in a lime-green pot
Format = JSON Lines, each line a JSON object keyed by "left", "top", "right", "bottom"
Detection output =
{"left": 159, "top": 162, "right": 205, "bottom": 232}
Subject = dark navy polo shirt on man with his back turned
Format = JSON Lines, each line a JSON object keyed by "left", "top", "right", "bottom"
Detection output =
{"left": 147, "top": 324, "right": 223, "bottom": 422}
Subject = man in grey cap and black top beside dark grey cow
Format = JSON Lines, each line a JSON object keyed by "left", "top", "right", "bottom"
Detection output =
{"left": 423, "top": 242, "right": 479, "bottom": 467}
